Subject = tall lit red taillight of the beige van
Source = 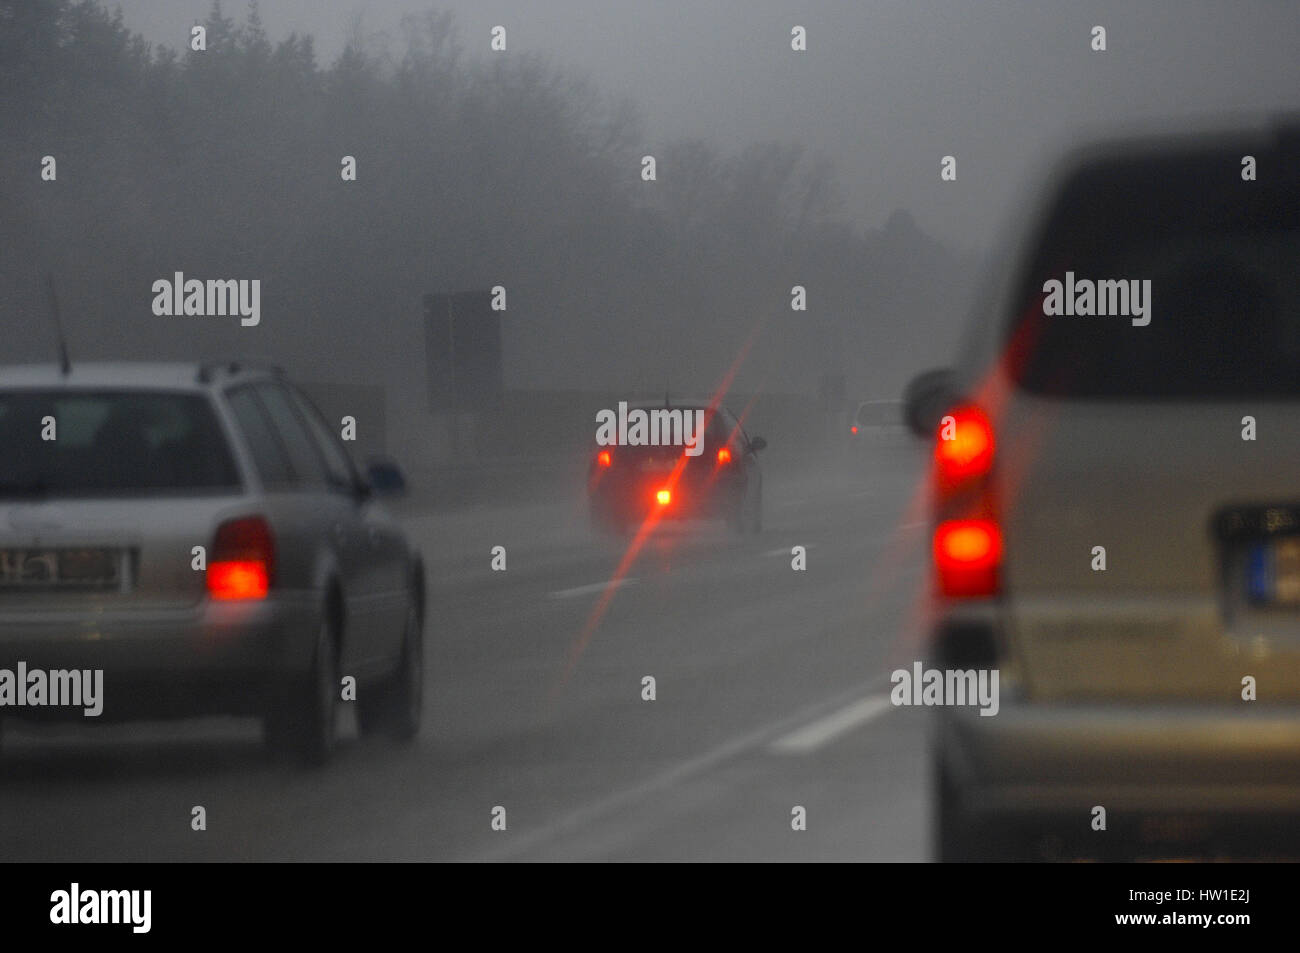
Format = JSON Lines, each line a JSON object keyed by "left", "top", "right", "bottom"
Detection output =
{"left": 933, "top": 404, "right": 1002, "bottom": 598}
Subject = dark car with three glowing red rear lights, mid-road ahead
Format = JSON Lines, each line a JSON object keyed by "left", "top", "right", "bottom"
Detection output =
{"left": 588, "top": 400, "right": 767, "bottom": 536}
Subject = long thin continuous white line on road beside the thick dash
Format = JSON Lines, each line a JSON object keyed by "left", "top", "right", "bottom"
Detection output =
{"left": 471, "top": 679, "right": 887, "bottom": 862}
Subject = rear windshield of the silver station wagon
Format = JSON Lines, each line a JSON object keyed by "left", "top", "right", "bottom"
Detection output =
{"left": 0, "top": 390, "right": 239, "bottom": 499}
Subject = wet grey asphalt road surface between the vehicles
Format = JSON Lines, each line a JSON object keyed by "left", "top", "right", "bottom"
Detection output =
{"left": 0, "top": 432, "right": 928, "bottom": 861}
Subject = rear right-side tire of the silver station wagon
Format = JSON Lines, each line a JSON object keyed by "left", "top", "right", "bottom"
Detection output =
{"left": 263, "top": 610, "right": 339, "bottom": 767}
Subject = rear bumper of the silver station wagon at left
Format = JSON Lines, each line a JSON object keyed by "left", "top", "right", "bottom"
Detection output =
{"left": 0, "top": 593, "right": 320, "bottom": 720}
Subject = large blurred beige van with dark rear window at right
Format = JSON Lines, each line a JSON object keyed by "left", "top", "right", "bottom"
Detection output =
{"left": 932, "top": 122, "right": 1300, "bottom": 859}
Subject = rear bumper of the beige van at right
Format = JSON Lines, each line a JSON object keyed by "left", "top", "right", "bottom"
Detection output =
{"left": 936, "top": 698, "right": 1300, "bottom": 832}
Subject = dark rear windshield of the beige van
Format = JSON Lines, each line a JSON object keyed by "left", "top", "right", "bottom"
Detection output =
{"left": 1005, "top": 143, "right": 1300, "bottom": 399}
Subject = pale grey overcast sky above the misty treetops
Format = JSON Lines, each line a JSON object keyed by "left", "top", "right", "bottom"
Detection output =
{"left": 109, "top": 0, "right": 1300, "bottom": 250}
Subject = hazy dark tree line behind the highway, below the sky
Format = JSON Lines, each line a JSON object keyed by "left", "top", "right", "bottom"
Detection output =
{"left": 0, "top": 0, "right": 971, "bottom": 397}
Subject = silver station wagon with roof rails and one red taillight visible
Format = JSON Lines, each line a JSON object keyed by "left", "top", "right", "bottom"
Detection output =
{"left": 0, "top": 363, "right": 425, "bottom": 763}
